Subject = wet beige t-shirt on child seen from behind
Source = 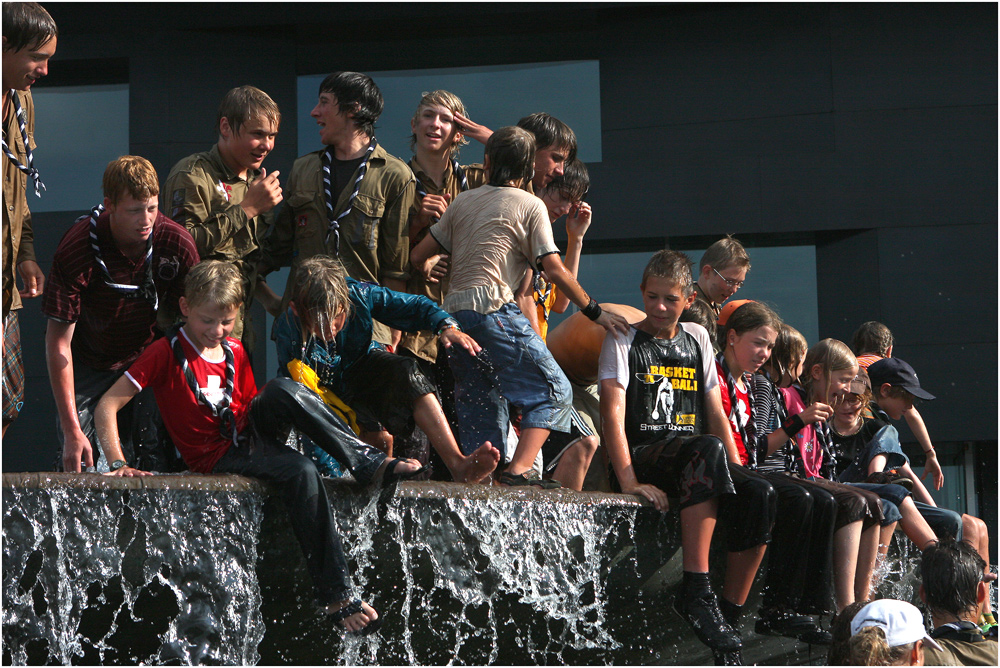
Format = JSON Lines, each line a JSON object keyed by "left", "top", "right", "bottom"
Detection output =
{"left": 430, "top": 185, "right": 559, "bottom": 314}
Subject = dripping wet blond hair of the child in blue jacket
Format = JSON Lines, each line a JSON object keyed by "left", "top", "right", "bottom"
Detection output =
{"left": 291, "top": 255, "right": 351, "bottom": 337}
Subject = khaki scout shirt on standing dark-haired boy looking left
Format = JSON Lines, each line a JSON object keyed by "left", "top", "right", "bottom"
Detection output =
{"left": 262, "top": 138, "right": 416, "bottom": 343}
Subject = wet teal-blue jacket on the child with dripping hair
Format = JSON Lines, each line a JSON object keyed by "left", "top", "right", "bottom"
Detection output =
{"left": 272, "top": 277, "right": 451, "bottom": 394}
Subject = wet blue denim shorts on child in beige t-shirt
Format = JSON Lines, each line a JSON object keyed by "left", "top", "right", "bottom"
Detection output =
{"left": 448, "top": 304, "right": 573, "bottom": 459}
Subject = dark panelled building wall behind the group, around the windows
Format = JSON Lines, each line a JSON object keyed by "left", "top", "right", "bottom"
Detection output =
{"left": 3, "top": 3, "right": 997, "bottom": 470}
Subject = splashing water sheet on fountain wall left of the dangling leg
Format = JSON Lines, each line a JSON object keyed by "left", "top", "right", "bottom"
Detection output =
{"left": 3, "top": 475, "right": 264, "bottom": 665}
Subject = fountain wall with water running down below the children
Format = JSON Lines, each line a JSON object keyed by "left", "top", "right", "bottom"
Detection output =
{"left": 3, "top": 474, "right": 928, "bottom": 665}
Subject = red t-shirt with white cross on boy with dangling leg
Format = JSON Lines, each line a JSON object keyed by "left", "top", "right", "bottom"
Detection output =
{"left": 125, "top": 328, "right": 257, "bottom": 473}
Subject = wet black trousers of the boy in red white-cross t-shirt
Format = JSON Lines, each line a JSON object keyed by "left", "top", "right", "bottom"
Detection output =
{"left": 213, "top": 378, "right": 385, "bottom": 605}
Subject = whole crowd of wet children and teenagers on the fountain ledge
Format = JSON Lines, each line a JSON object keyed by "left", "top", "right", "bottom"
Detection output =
{"left": 4, "top": 3, "right": 988, "bottom": 663}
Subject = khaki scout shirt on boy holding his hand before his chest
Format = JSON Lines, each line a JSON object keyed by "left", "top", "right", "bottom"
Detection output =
{"left": 164, "top": 145, "right": 271, "bottom": 350}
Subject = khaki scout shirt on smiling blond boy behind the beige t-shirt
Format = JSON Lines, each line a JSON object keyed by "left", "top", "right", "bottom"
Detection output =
{"left": 399, "top": 158, "right": 486, "bottom": 362}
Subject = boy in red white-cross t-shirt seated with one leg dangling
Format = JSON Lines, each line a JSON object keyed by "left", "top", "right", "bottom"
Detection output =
{"left": 95, "top": 260, "right": 420, "bottom": 634}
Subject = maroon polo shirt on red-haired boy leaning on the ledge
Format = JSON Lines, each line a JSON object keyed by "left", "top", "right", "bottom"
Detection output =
{"left": 42, "top": 213, "right": 198, "bottom": 370}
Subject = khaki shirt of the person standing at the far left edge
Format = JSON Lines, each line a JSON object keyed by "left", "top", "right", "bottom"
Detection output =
{"left": 0, "top": 91, "right": 35, "bottom": 318}
